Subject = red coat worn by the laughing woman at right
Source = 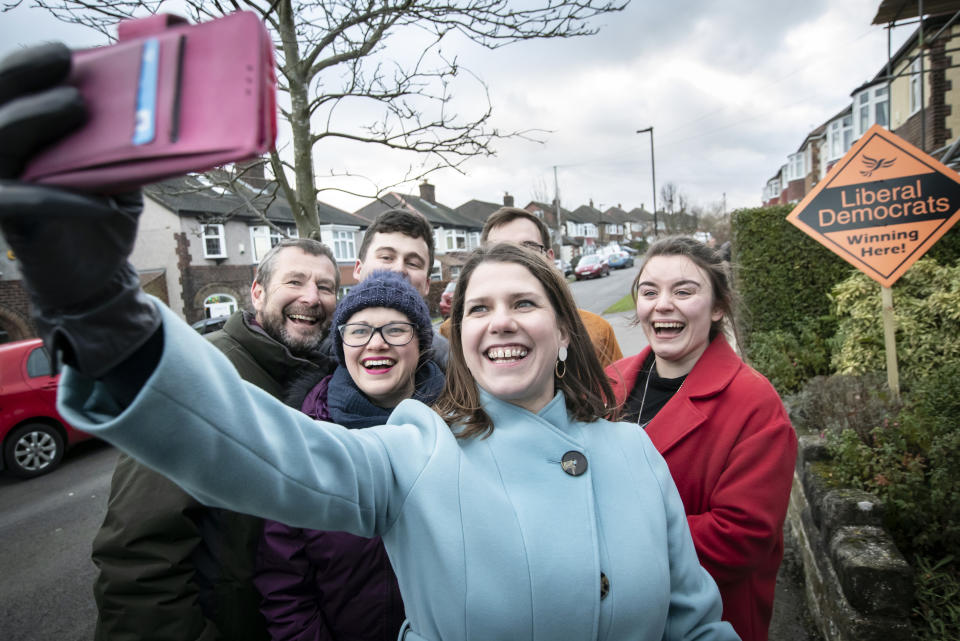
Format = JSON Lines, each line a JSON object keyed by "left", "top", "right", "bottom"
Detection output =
{"left": 606, "top": 335, "right": 797, "bottom": 641}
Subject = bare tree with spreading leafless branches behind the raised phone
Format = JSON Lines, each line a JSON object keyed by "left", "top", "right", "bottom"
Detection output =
{"left": 11, "top": 0, "right": 629, "bottom": 236}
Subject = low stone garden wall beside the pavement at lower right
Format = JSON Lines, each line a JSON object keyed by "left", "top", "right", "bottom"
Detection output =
{"left": 786, "top": 436, "right": 913, "bottom": 641}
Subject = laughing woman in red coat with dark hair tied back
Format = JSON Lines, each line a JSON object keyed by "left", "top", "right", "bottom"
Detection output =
{"left": 607, "top": 237, "right": 797, "bottom": 641}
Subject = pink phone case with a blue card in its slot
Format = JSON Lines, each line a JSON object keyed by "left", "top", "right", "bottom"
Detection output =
{"left": 22, "top": 11, "right": 277, "bottom": 192}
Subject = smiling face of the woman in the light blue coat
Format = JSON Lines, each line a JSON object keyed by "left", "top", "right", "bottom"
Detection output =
{"left": 460, "top": 261, "right": 569, "bottom": 412}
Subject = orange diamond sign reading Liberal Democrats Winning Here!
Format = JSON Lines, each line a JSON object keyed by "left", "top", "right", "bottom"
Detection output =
{"left": 787, "top": 125, "right": 960, "bottom": 287}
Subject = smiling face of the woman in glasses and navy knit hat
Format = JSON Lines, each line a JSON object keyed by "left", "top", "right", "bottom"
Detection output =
{"left": 343, "top": 307, "right": 420, "bottom": 408}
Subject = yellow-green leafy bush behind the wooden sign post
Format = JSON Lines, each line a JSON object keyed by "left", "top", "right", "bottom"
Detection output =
{"left": 831, "top": 258, "right": 960, "bottom": 380}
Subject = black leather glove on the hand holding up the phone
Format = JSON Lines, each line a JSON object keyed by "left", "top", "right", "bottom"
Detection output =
{"left": 0, "top": 44, "right": 160, "bottom": 378}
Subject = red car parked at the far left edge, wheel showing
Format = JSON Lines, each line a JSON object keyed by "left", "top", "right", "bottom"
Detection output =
{"left": 0, "top": 338, "right": 91, "bottom": 478}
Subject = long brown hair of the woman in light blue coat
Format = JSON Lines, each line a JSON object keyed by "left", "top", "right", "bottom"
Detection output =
{"left": 435, "top": 243, "right": 614, "bottom": 438}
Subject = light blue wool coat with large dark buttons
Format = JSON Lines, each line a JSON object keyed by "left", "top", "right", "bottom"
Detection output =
{"left": 59, "top": 306, "right": 737, "bottom": 641}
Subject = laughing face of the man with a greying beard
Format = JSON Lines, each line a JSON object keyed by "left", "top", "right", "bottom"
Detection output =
{"left": 250, "top": 247, "right": 337, "bottom": 356}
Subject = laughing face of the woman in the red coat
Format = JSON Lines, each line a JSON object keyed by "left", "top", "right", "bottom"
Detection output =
{"left": 637, "top": 255, "right": 723, "bottom": 378}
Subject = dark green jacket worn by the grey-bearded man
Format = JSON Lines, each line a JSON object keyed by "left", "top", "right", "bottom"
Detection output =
{"left": 93, "top": 312, "right": 333, "bottom": 641}
